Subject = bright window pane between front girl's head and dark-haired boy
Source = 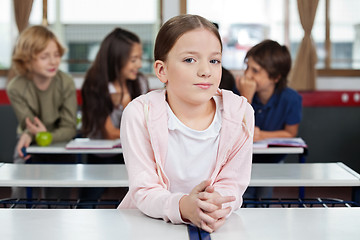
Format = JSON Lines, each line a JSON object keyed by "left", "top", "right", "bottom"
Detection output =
{"left": 187, "top": 0, "right": 284, "bottom": 70}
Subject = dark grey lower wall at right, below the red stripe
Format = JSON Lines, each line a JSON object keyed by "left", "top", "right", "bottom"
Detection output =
{"left": 285, "top": 106, "right": 360, "bottom": 173}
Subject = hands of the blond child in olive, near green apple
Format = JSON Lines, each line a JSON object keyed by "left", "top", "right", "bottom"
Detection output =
{"left": 16, "top": 117, "right": 47, "bottom": 160}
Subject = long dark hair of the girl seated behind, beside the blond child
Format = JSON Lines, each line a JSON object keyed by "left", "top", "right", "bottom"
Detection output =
{"left": 81, "top": 28, "right": 141, "bottom": 136}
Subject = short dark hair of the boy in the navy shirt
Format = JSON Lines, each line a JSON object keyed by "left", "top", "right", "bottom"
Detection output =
{"left": 245, "top": 40, "right": 291, "bottom": 91}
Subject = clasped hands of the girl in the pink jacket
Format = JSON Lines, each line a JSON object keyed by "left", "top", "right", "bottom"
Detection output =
{"left": 179, "top": 179, "right": 235, "bottom": 233}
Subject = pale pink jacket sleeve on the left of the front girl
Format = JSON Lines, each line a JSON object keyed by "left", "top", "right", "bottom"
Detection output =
{"left": 120, "top": 99, "right": 184, "bottom": 223}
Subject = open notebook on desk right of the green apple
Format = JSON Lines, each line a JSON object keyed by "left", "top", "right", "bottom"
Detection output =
{"left": 65, "top": 138, "right": 121, "bottom": 149}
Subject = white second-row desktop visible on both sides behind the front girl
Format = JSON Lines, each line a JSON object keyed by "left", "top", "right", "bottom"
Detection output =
{"left": 0, "top": 162, "right": 360, "bottom": 187}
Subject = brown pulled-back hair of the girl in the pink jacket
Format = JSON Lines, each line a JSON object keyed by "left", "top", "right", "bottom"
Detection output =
{"left": 154, "top": 14, "right": 222, "bottom": 61}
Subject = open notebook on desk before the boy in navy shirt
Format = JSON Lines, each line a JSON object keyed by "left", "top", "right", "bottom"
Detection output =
{"left": 253, "top": 138, "right": 307, "bottom": 148}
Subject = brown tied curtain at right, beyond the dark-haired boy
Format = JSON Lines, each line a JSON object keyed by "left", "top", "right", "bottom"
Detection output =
{"left": 289, "top": 0, "right": 319, "bottom": 90}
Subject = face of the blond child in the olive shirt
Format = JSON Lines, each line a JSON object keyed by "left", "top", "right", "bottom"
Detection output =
{"left": 31, "top": 40, "right": 61, "bottom": 80}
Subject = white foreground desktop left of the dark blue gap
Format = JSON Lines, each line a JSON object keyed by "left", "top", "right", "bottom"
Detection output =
{"left": 0, "top": 209, "right": 189, "bottom": 240}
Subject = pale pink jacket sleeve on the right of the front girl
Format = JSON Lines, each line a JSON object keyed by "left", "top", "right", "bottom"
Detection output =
{"left": 213, "top": 100, "right": 254, "bottom": 211}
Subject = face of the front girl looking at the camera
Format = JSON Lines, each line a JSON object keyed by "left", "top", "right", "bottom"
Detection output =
{"left": 155, "top": 28, "right": 221, "bottom": 105}
